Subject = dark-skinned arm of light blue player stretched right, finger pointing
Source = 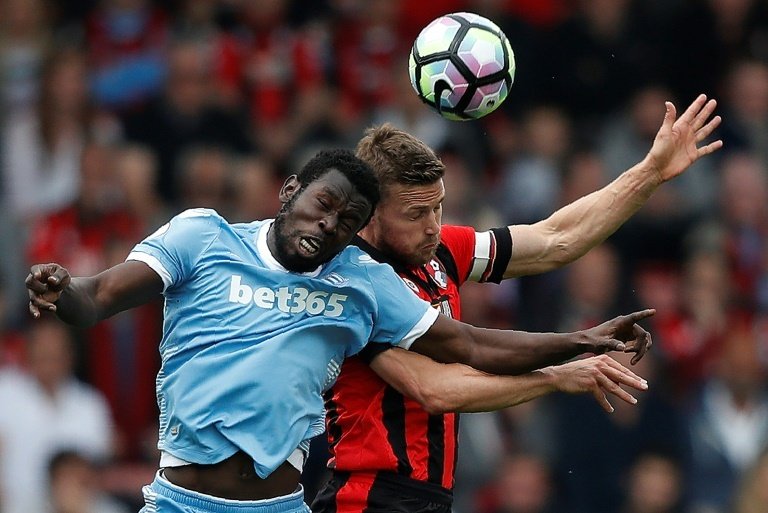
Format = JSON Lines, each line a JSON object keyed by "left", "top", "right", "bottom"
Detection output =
{"left": 410, "top": 310, "right": 656, "bottom": 374}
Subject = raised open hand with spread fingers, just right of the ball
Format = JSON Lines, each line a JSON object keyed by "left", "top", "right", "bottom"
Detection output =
{"left": 647, "top": 94, "right": 723, "bottom": 182}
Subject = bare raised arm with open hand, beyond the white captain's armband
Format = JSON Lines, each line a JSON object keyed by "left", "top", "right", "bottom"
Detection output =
{"left": 504, "top": 94, "right": 723, "bottom": 278}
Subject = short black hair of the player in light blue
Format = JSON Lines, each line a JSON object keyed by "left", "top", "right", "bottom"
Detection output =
{"left": 297, "top": 149, "right": 380, "bottom": 213}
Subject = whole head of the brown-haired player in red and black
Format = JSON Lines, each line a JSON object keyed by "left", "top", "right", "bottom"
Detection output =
{"left": 357, "top": 124, "right": 445, "bottom": 266}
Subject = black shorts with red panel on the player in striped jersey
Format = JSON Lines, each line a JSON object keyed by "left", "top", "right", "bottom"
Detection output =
{"left": 312, "top": 472, "right": 453, "bottom": 513}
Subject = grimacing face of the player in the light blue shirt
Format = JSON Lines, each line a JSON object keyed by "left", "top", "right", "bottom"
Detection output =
{"left": 267, "top": 169, "right": 371, "bottom": 272}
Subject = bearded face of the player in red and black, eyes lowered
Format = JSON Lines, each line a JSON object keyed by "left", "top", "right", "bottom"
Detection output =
{"left": 362, "top": 180, "right": 445, "bottom": 266}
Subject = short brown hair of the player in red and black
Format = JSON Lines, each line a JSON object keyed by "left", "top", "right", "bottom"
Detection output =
{"left": 356, "top": 123, "right": 445, "bottom": 188}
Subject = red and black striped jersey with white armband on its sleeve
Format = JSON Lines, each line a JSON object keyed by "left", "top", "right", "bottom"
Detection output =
{"left": 325, "top": 226, "right": 512, "bottom": 490}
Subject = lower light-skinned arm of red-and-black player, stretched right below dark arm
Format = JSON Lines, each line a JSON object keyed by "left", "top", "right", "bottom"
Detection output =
{"left": 370, "top": 348, "right": 648, "bottom": 415}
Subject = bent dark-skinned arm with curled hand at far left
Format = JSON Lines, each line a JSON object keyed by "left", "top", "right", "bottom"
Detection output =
{"left": 25, "top": 261, "right": 163, "bottom": 327}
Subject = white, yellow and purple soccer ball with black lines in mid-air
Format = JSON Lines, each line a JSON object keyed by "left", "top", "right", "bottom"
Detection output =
{"left": 408, "top": 12, "right": 515, "bottom": 121}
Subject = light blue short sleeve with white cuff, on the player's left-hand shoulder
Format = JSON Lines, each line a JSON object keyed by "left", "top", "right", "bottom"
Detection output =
{"left": 126, "top": 209, "right": 223, "bottom": 291}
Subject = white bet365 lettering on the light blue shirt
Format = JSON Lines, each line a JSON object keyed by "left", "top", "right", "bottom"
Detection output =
{"left": 229, "top": 275, "right": 347, "bottom": 317}
